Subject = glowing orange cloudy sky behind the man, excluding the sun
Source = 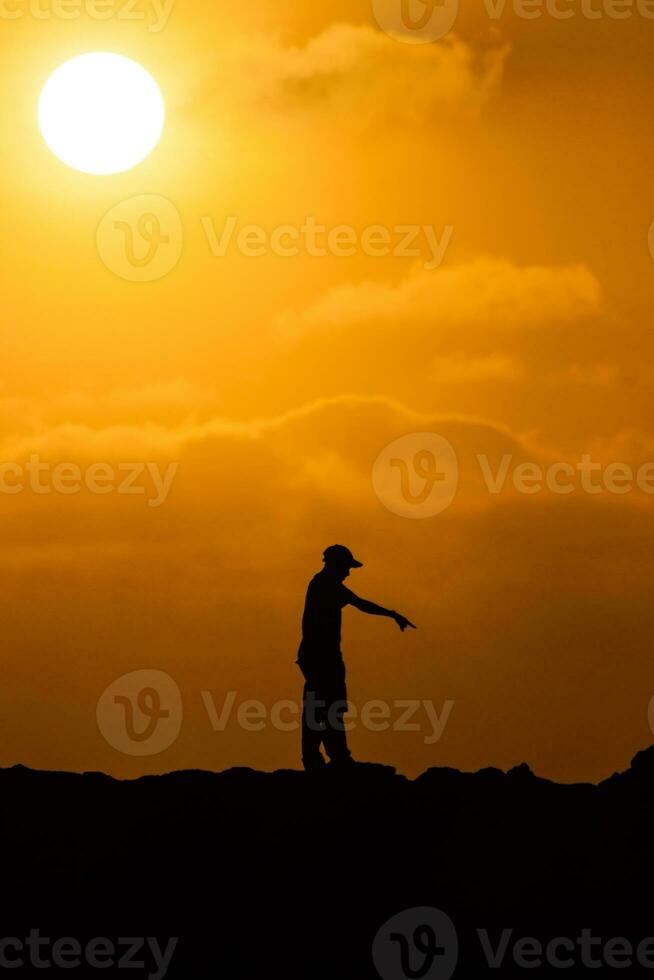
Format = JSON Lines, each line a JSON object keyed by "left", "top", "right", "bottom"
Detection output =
{"left": 0, "top": 0, "right": 654, "bottom": 780}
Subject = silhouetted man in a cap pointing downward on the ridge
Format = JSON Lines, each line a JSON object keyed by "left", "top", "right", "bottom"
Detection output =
{"left": 296, "top": 544, "right": 415, "bottom": 770}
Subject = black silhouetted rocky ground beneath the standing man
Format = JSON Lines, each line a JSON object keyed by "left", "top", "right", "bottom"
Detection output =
{"left": 0, "top": 747, "right": 654, "bottom": 980}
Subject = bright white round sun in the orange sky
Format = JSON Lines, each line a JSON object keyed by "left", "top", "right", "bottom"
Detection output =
{"left": 39, "top": 52, "right": 165, "bottom": 174}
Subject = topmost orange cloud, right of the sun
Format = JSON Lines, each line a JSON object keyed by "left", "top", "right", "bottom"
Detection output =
{"left": 202, "top": 23, "right": 508, "bottom": 126}
